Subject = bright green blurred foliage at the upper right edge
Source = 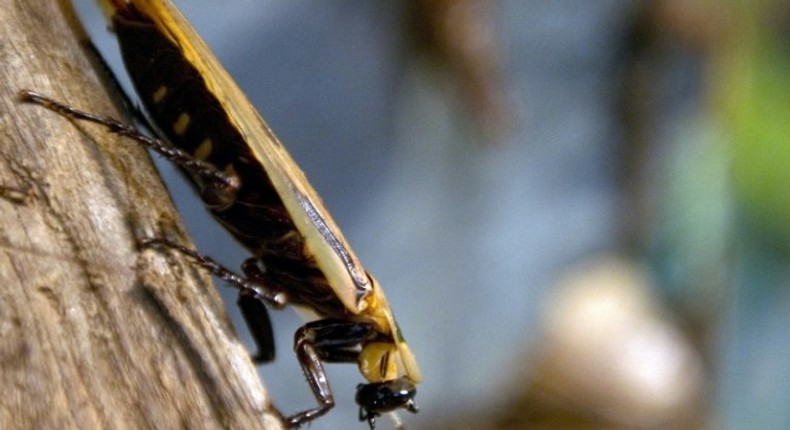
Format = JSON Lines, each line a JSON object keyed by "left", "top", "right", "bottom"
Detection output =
{"left": 723, "top": 1, "right": 790, "bottom": 251}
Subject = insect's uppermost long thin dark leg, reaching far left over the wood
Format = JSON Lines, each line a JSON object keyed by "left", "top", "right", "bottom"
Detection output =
{"left": 19, "top": 90, "right": 241, "bottom": 208}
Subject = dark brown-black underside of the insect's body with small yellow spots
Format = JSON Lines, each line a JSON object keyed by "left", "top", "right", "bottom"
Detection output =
{"left": 112, "top": 4, "right": 346, "bottom": 315}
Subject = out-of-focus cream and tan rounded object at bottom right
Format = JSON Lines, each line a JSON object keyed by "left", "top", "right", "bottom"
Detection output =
{"left": 439, "top": 257, "right": 709, "bottom": 430}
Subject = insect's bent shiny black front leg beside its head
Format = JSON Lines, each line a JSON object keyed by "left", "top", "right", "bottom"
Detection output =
{"left": 288, "top": 319, "right": 376, "bottom": 426}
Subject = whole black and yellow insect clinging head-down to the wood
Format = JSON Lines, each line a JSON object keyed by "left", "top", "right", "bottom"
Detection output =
{"left": 22, "top": 0, "right": 422, "bottom": 428}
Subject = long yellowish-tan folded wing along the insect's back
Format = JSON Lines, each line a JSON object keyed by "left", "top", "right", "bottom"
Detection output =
{"left": 106, "top": 0, "right": 372, "bottom": 314}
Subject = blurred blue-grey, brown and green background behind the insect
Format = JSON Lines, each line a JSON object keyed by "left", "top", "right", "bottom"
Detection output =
{"left": 79, "top": 0, "right": 790, "bottom": 429}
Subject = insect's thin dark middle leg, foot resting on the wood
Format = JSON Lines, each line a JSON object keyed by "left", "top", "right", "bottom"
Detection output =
{"left": 140, "top": 238, "right": 288, "bottom": 310}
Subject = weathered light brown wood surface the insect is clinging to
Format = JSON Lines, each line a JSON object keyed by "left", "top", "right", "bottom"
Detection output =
{"left": 0, "top": 0, "right": 282, "bottom": 429}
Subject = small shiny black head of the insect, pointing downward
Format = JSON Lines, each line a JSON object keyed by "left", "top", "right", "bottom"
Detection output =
{"left": 356, "top": 378, "right": 419, "bottom": 423}
